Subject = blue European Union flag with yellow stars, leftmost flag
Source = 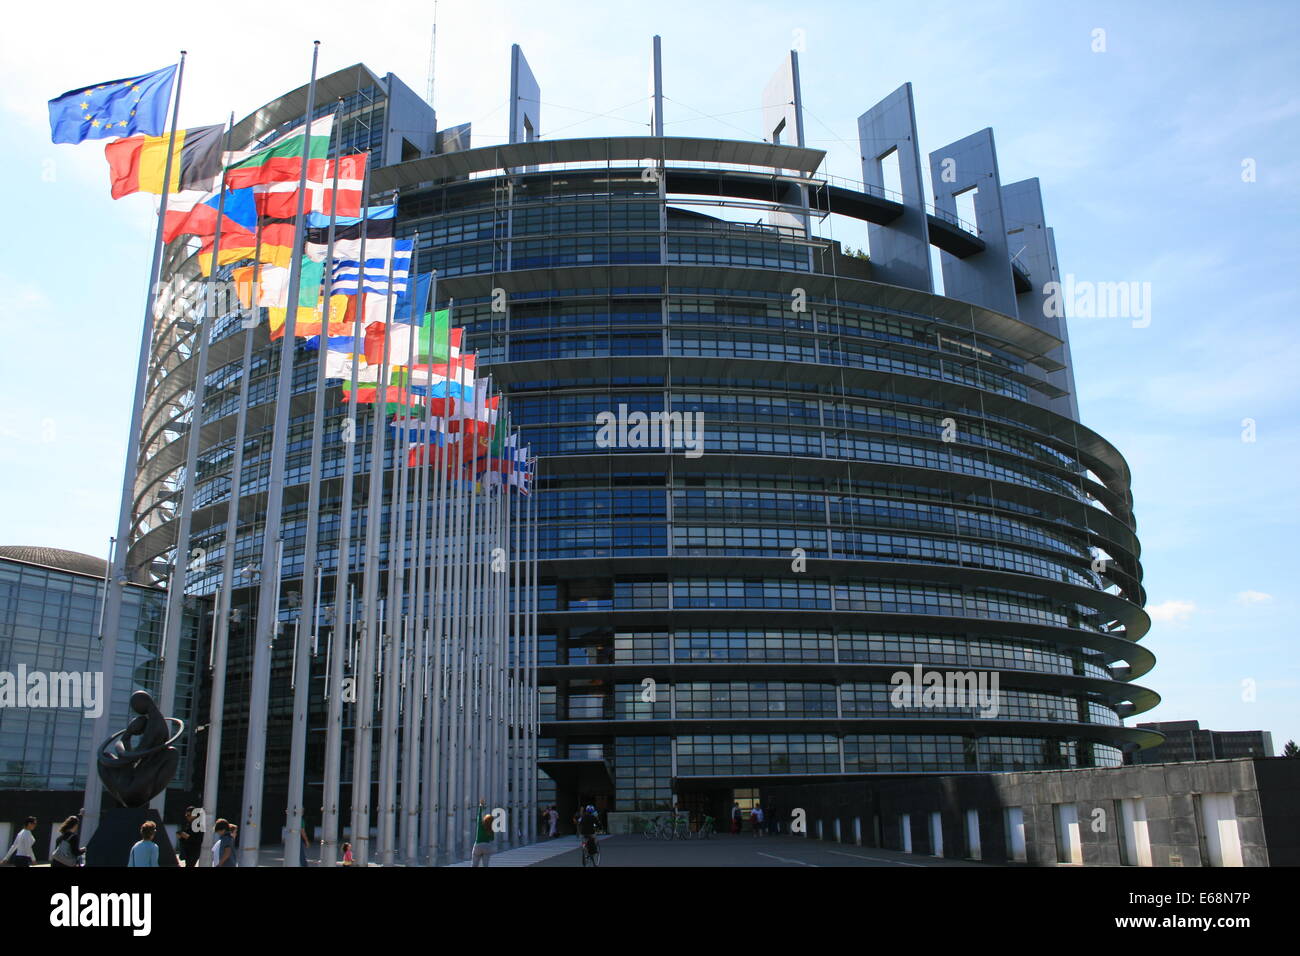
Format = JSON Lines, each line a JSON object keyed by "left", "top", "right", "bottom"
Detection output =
{"left": 49, "top": 65, "right": 176, "bottom": 143}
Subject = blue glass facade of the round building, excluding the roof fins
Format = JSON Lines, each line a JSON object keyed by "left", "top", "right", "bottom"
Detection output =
{"left": 129, "top": 76, "right": 1149, "bottom": 810}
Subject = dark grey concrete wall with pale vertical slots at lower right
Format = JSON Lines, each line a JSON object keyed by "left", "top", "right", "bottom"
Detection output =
{"left": 761, "top": 757, "right": 1300, "bottom": 866}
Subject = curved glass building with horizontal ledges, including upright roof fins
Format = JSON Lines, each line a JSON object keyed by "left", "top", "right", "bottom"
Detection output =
{"left": 124, "top": 48, "right": 1158, "bottom": 832}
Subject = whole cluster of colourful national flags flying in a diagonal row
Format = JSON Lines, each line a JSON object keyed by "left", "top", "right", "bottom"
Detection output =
{"left": 49, "top": 66, "right": 532, "bottom": 494}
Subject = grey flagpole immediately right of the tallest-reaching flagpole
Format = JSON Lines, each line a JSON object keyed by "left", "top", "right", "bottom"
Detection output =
{"left": 285, "top": 96, "right": 343, "bottom": 868}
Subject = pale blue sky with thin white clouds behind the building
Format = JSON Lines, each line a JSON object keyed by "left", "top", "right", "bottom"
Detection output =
{"left": 0, "top": 0, "right": 1300, "bottom": 748}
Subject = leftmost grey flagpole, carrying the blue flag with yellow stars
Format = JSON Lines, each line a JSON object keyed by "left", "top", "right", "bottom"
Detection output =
{"left": 81, "top": 49, "right": 186, "bottom": 843}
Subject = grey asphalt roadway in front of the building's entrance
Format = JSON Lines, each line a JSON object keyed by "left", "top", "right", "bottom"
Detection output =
{"left": 533, "top": 834, "right": 983, "bottom": 868}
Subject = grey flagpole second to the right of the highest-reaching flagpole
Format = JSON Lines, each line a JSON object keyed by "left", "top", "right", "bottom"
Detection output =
{"left": 321, "top": 153, "right": 371, "bottom": 866}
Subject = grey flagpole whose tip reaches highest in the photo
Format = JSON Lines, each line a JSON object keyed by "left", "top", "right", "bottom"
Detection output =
{"left": 239, "top": 40, "right": 320, "bottom": 866}
